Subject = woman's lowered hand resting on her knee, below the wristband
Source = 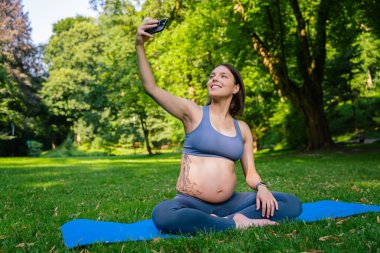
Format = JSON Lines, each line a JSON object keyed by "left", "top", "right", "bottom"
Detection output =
{"left": 256, "top": 185, "right": 278, "bottom": 219}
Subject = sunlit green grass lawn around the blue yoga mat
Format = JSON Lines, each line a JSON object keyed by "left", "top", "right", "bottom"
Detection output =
{"left": 0, "top": 144, "right": 380, "bottom": 252}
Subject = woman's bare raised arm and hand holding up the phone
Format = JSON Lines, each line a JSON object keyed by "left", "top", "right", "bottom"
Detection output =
{"left": 135, "top": 19, "right": 197, "bottom": 122}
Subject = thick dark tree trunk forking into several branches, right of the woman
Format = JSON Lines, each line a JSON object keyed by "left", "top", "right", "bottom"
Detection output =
{"left": 235, "top": 0, "right": 333, "bottom": 150}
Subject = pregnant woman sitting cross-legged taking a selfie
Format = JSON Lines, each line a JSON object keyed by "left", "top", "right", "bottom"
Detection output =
{"left": 136, "top": 20, "right": 302, "bottom": 233}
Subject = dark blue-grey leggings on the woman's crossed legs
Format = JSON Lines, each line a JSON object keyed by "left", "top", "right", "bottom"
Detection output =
{"left": 152, "top": 192, "right": 302, "bottom": 234}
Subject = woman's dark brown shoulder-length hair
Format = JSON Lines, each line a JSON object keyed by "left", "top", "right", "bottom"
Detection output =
{"left": 207, "top": 63, "right": 245, "bottom": 116}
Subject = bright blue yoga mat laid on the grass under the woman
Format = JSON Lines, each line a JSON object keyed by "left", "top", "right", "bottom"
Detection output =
{"left": 62, "top": 200, "right": 380, "bottom": 248}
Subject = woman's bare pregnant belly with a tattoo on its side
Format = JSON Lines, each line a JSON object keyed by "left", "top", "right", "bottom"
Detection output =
{"left": 177, "top": 154, "right": 236, "bottom": 203}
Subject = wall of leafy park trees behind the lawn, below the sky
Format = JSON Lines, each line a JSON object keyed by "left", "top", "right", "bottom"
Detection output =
{"left": 0, "top": 0, "right": 380, "bottom": 156}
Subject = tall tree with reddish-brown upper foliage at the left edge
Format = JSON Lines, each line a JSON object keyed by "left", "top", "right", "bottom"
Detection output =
{"left": 0, "top": 0, "right": 43, "bottom": 155}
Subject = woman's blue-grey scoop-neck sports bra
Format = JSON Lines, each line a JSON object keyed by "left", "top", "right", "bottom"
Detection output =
{"left": 182, "top": 106, "right": 244, "bottom": 161}
